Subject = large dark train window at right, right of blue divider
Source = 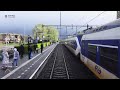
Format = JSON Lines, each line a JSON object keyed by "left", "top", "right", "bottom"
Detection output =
{"left": 100, "top": 47, "right": 118, "bottom": 74}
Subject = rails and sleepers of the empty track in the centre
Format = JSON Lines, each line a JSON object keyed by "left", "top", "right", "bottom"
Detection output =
{"left": 50, "top": 46, "right": 69, "bottom": 79}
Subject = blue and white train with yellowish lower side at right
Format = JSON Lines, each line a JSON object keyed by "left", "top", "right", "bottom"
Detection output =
{"left": 64, "top": 19, "right": 120, "bottom": 79}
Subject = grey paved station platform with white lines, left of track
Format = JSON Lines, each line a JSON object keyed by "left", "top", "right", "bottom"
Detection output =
{"left": 0, "top": 44, "right": 56, "bottom": 79}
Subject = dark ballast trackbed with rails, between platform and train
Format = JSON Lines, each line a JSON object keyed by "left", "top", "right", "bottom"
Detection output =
{"left": 37, "top": 44, "right": 95, "bottom": 79}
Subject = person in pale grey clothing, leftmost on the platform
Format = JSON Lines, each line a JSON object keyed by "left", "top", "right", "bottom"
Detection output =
{"left": 2, "top": 49, "right": 9, "bottom": 68}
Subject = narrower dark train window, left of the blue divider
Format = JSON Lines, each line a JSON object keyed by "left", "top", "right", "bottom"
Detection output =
{"left": 88, "top": 45, "right": 97, "bottom": 62}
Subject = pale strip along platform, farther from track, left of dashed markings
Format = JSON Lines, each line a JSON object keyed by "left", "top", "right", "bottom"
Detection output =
{"left": 1, "top": 46, "right": 52, "bottom": 79}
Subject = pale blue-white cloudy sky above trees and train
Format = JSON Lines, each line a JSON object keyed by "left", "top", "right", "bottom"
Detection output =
{"left": 0, "top": 11, "right": 117, "bottom": 33}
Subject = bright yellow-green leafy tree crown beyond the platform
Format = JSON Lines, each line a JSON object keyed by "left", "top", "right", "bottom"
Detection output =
{"left": 33, "top": 24, "right": 59, "bottom": 42}
